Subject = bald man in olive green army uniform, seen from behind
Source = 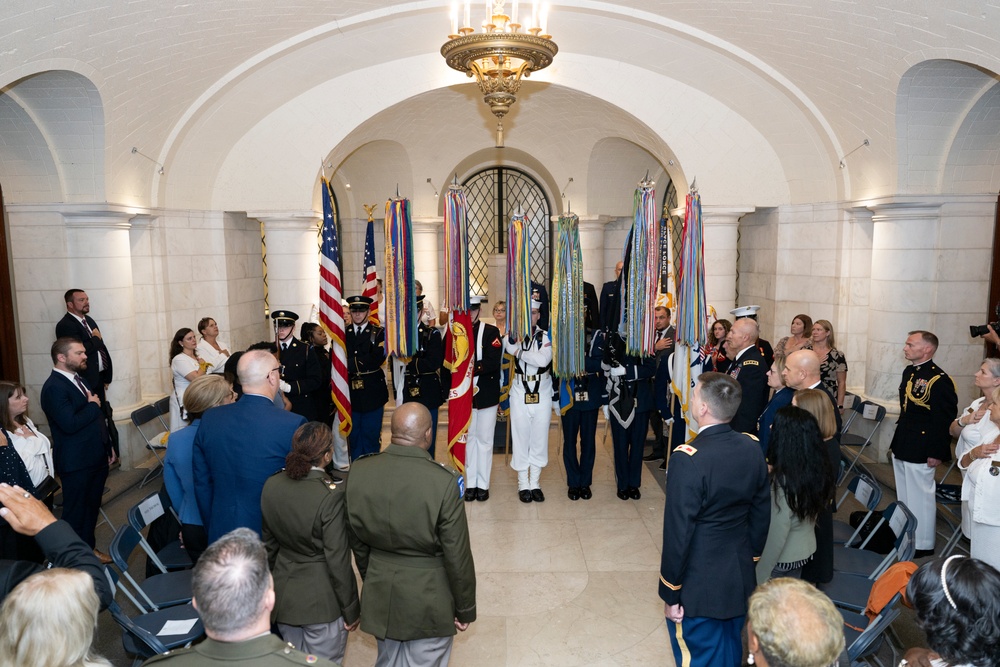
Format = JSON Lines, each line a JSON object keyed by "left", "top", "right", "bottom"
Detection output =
{"left": 346, "top": 403, "right": 476, "bottom": 667}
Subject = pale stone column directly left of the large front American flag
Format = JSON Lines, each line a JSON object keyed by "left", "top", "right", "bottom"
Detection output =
{"left": 254, "top": 211, "right": 322, "bottom": 324}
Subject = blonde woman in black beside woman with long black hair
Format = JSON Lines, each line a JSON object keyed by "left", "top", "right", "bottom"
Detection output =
{"left": 792, "top": 389, "right": 840, "bottom": 584}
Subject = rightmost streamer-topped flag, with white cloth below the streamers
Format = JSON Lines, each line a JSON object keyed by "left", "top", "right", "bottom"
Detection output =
{"left": 670, "top": 188, "right": 708, "bottom": 439}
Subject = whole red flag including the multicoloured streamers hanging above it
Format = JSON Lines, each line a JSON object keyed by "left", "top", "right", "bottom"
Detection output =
{"left": 444, "top": 183, "right": 475, "bottom": 473}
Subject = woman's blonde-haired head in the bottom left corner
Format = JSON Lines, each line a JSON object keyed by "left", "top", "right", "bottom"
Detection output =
{"left": 0, "top": 568, "right": 111, "bottom": 667}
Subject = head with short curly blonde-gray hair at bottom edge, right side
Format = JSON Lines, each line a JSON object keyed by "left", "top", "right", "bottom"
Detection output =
{"left": 747, "top": 577, "right": 844, "bottom": 667}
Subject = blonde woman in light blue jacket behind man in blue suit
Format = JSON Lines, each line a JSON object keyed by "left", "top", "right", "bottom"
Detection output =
{"left": 163, "top": 375, "right": 236, "bottom": 563}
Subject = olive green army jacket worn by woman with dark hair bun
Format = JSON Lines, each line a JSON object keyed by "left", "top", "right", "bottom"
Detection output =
{"left": 260, "top": 470, "right": 361, "bottom": 626}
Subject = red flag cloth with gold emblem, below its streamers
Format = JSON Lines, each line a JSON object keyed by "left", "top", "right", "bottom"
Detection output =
{"left": 444, "top": 310, "right": 474, "bottom": 473}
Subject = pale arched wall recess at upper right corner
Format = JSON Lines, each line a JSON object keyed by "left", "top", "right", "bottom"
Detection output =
{"left": 896, "top": 59, "right": 1000, "bottom": 194}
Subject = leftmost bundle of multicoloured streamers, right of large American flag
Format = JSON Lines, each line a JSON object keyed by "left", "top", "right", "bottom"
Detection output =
{"left": 382, "top": 198, "right": 420, "bottom": 359}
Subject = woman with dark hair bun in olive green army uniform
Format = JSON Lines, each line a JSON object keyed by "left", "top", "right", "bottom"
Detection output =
{"left": 260, "top": 422, "right": 361, "bottom": 664}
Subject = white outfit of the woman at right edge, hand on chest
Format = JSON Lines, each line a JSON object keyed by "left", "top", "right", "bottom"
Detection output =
{"left": 958, "top": 389, "right": 1000, "bottom": 568}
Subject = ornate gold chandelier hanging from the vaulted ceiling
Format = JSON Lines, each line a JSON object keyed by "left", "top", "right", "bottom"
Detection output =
{"left": 441, "top": 0, "right": 559, "bottom": 148}
